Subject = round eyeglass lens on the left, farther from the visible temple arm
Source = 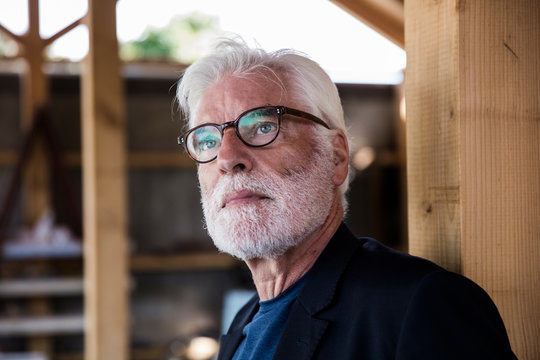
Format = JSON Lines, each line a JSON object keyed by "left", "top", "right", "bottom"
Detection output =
{"left": 186, "top": 125, "right": 221, "bottom": 161}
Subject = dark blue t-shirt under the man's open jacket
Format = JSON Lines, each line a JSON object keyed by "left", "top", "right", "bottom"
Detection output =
{"left": 233, "top": 275, "right": 306, "bottom": 360}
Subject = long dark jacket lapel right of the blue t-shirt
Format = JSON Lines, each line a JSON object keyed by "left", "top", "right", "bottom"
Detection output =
{"left": 274, "top": 224, "right": 362, "bottom": 360}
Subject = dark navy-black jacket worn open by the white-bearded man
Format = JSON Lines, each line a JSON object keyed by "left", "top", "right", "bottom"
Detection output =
{"left": 218, "top": 225, "right": 516, "bottom": 360}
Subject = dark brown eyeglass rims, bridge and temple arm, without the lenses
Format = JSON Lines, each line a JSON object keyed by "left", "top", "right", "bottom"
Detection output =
{"left": 177, "top": 105, "right": 330, "bottom": 164}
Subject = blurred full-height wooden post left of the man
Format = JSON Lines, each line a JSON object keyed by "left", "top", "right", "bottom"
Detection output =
{"left": 82, "top": 0, "right": 129, "bottom": 360}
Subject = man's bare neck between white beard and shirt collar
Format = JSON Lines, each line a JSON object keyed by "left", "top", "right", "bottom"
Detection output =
{"left": 246, "top": 196, "right": 343, "bottom": 301}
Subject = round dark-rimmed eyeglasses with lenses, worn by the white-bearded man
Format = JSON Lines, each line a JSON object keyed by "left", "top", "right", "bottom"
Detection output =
{"left": 178, "top": 106, "right": 330, "bottom": 164}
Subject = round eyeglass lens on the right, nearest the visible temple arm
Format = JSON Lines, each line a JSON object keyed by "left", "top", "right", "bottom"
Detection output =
{"left": 238, "top": 108, "right": 279, "bottom": 146}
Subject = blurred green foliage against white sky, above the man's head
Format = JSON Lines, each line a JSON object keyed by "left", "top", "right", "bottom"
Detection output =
{"left": 120, "top": 13, "right": 220, "bottom": 63}
